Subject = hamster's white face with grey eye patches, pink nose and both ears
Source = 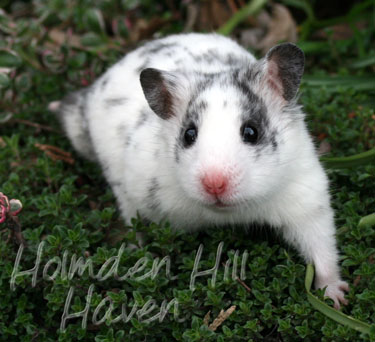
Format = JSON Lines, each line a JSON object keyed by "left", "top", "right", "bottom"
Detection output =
{"left": 140, "top": 43, "right": 304, "bottom": 212}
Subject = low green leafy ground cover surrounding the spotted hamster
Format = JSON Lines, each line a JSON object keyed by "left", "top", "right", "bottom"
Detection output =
{"left": 0, "top": 0, "right": 375, "bottom": 342}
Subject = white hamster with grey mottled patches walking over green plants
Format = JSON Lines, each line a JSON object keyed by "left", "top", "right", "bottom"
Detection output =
{"left": 55, "top": 33, "right": 348, "bottom": 308}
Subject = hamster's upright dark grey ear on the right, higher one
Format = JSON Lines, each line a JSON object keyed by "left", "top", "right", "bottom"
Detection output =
{"left": 265, "top": 43, "right": 305, "bottom": 101}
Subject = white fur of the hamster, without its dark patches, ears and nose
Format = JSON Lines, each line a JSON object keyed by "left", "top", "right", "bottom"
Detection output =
{"left": 58, "top": 34, "right": 347, "bottom": 307}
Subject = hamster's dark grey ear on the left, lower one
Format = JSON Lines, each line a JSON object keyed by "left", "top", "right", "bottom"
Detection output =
{"left": 140, "top": 68, "right": 185, "bottom": 120}
